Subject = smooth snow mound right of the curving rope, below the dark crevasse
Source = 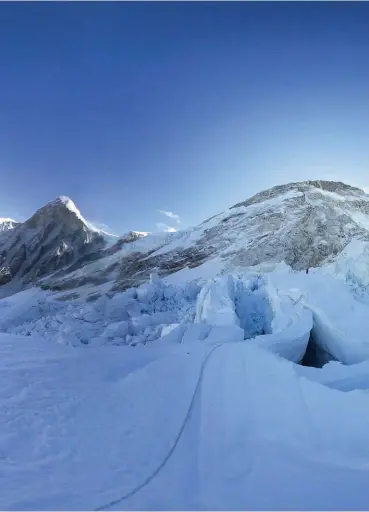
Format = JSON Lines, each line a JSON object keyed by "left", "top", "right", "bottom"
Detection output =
{"left": 112, "top": 342, "right": 369, "bottom": 510}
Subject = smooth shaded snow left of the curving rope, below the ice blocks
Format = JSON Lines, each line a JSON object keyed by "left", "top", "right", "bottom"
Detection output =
{"left": 0, "top": 335, "right": 210, "bottom": 510}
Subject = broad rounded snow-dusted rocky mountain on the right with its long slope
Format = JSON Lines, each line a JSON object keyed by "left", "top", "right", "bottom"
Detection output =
{"left": 96, "top": 180, "right": 369, "bottom": 288}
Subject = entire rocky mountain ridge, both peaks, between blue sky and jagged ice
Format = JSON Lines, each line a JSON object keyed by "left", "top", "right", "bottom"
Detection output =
{"left": 0, "top": 181, "right": 369, "bottom": 293}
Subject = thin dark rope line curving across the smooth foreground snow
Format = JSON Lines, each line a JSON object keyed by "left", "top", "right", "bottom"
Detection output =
{"left": 93, "top": 341, "right": 227, "bottom": 512}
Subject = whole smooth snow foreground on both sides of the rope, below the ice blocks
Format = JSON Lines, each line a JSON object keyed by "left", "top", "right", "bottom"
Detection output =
{"left": 0, "top": 334, "right": 369, "bottom": 510}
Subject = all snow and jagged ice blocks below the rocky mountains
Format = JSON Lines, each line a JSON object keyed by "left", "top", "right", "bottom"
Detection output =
{"left": 0, "top": 254, "right": 369, "bottom": 510}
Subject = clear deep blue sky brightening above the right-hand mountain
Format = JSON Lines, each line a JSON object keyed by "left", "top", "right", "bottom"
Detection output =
{"left": 0, "top": 2, "right": 369, "bottom": 233}
